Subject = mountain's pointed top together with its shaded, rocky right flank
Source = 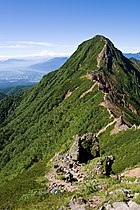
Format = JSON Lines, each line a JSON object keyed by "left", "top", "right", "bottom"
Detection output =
{"left": 64, "top": 35, "right": 140, "bottom": 125}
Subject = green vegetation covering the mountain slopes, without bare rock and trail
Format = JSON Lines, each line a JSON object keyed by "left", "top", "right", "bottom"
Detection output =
{"left": 0, "top": 36, "right": 140, "bottom": 209}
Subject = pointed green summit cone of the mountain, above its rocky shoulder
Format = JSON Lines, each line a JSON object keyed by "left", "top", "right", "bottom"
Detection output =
{"left": 65, "top": 35, "right": 123, "bottom": 72}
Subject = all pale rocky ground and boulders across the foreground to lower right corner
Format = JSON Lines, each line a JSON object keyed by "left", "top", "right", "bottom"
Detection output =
{"left": 45, "top": 134, "right": 140, "bottom": 210}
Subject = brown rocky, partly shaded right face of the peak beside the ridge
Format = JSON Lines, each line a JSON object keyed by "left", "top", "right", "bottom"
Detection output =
{"left": 87, "top": 37, "right": 139, "bottom": 126}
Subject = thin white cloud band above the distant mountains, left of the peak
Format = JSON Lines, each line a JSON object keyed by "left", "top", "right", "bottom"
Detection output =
{"left": 0, "top": 41, "right": 75, "bottom": 60}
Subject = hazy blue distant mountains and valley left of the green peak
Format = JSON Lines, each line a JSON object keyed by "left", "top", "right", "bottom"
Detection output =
{"left": 0, "top": 57, "right": 68, "bottom": 88}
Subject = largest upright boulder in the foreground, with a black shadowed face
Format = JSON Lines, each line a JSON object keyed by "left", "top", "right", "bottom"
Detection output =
{"left": 69, "top": 133, "right": 100, "bottom": 163}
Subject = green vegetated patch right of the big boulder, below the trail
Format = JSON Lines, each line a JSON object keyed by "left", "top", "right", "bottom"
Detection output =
{"left": 99, "top": 126, "right": 140, "bottom": 173}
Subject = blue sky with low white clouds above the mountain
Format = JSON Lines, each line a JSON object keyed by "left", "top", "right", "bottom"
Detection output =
{"left": 0, "top": 0, "right": 140, "bottom": 60}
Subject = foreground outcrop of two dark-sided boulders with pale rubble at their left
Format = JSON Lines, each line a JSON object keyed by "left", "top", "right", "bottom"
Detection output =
{"left": 45, "top": 133, "right": 114, "bottom": 192}
